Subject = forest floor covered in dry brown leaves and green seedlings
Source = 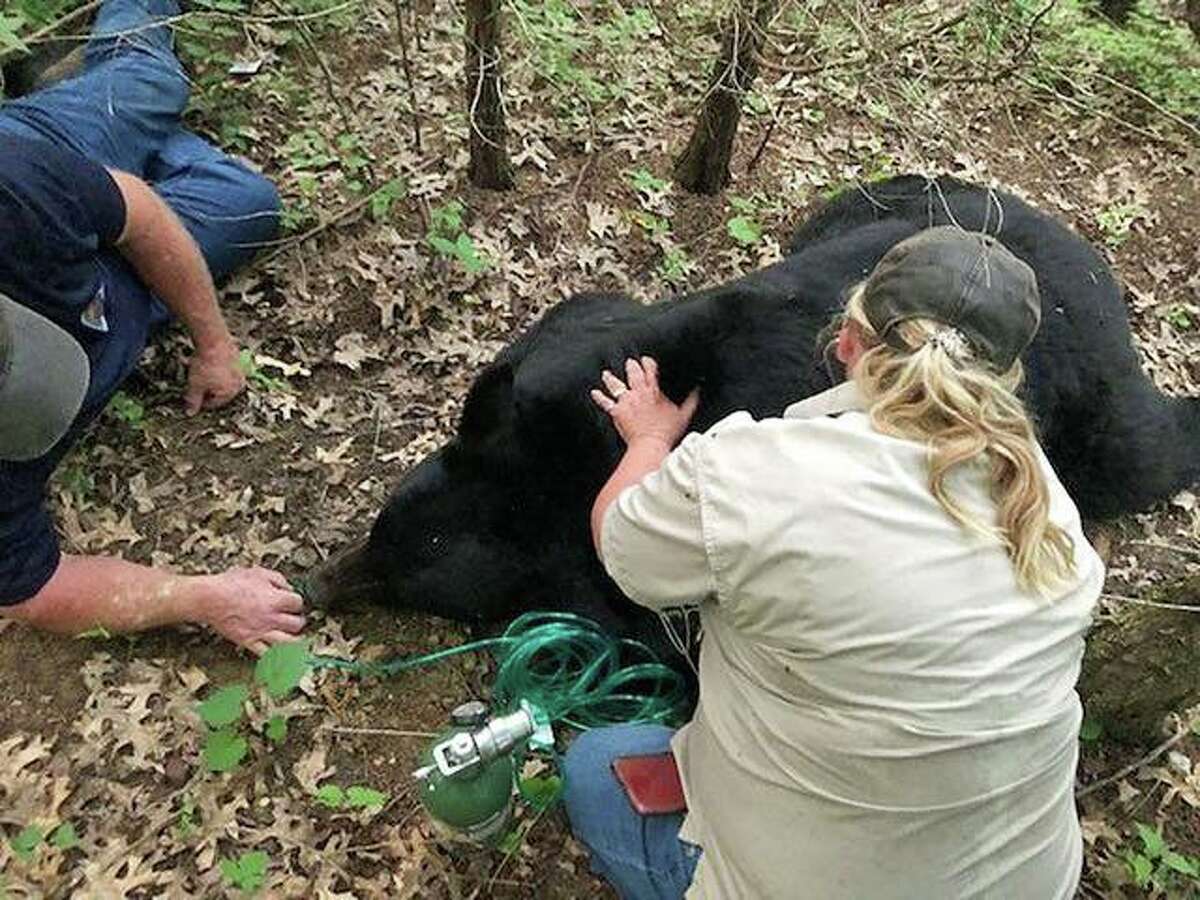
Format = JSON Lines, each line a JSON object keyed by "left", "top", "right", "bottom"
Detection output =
{"left": 0, "top": 0, "right": 1200, "bottom": 900}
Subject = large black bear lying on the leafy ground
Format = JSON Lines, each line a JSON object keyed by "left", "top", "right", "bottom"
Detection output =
{"left": 316, "top": 176, "right": 1200, "bottom": 667}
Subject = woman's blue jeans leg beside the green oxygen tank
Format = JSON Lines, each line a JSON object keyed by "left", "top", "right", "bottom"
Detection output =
{"left": 563, "top": 725, "right": 700, "bottom": 900}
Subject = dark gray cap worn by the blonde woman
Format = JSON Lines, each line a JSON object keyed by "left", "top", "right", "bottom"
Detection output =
{"left": 863, "top": 226, "right": 1042, "bottom": 372}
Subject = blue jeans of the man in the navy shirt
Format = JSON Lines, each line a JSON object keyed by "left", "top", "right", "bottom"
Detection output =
{"left": 0, "top": 0, "right": 280, "bottom": 285}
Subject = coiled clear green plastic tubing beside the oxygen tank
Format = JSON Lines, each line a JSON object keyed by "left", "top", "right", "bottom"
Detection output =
{"left": 304, "top": 612, "right": 691, "bottom": 730}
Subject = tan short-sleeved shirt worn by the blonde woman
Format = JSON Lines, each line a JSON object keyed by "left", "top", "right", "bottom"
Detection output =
{"left": 601, "top": 383, "right": 1104, "bottom": 900}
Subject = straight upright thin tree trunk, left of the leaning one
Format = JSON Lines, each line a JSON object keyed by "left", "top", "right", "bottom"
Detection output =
{"left": 466, "top": 0, "right": 512, "bottom": 191}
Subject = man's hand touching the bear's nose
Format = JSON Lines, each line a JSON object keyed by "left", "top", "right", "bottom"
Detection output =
{"left": 198, "top": 569, "right": 305, "bottom": 655}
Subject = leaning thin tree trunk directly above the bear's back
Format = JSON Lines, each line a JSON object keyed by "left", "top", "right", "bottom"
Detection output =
{"left": 674, "top": 0, "right": 779, "bottom": 194}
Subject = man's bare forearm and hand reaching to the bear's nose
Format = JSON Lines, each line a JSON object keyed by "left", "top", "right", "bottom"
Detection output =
{"left": 0, "top": 556, "right": 305, "bottom": 653}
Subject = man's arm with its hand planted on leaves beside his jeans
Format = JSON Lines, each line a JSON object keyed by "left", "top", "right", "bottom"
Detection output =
{"left": 109, "top": 169, "right": 246, "bottom": 414}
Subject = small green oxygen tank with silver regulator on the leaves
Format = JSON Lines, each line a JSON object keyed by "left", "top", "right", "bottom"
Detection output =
{"left": 413, "top": 700, "right": 539, "bottom": 846}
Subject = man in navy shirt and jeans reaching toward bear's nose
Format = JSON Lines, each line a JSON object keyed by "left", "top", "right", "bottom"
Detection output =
{"left": 0, "top": 0, "right": 304, "bottom": 653}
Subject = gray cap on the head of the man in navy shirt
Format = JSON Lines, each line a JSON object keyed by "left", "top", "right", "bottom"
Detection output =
{"left": 0, "top": 294, "right": 91, "bottom": 462}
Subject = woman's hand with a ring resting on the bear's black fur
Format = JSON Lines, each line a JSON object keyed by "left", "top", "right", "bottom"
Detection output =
{"left": 592, "top": 356, "right": 700, "bottom": 450}
